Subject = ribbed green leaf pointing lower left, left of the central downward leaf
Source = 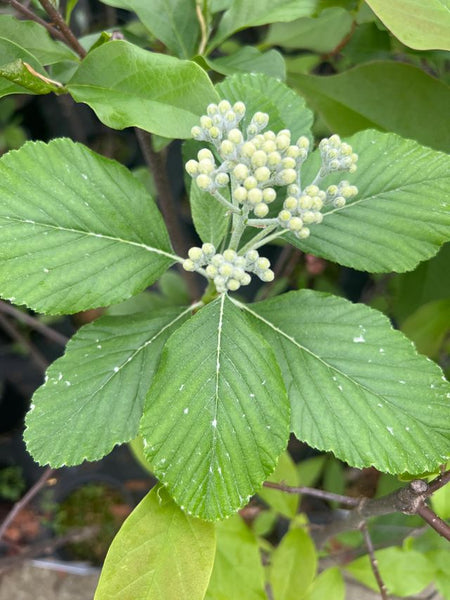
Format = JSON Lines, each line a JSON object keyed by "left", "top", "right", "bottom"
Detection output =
{"left": 24, "top": 308, "right": 190, "bottom": 467}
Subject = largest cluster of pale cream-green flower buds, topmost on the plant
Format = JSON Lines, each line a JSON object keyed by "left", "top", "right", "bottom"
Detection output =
{"left": 186, "top": 100, "right": 309, "bottom": 218}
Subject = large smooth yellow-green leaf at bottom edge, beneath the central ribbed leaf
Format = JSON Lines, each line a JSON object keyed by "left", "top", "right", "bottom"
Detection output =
{"left": 94, "top": 486, "right": 215, "bottom": 600}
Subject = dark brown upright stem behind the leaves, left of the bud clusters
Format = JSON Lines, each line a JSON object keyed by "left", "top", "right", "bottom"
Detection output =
{"left": 134, "top": 127, "right": 201, "bottom": 300}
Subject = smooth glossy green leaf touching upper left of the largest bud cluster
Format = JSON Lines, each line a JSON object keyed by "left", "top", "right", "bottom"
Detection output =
{"left": 67, "top": 40, "right": 217, "bottom": 138}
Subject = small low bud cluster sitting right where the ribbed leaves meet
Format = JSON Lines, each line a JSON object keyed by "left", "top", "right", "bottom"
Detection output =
{"left": 183, "top": 243, "right": 274, "bottom": 293}
